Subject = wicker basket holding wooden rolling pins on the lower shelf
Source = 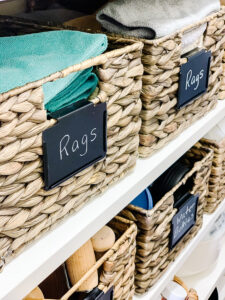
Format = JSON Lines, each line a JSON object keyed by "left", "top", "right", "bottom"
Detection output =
{"left": 61, "top": 217, "right": 137, "bottom": 300}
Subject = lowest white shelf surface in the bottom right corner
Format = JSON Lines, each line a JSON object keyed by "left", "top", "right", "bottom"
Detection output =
{"left": 182, "top": 244, "right": 225, "bottom": 300}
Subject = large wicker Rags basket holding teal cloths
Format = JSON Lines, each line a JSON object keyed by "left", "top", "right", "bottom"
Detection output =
{"left": 0, "top": 17, "right": 143, "bottom": 267}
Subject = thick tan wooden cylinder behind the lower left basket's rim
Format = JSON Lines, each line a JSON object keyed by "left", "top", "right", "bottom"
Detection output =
{"left": 66, "top": 240, "right": 98, "bottom": 292}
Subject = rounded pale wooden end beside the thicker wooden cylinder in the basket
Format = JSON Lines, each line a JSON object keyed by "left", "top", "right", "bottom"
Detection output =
{"left": 91, "top": 226, "right": 116, "bottom": 259}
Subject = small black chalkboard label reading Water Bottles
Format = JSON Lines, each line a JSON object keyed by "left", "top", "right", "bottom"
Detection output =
{"left": 170, "top": 194, "right": 198, "bottom": 249}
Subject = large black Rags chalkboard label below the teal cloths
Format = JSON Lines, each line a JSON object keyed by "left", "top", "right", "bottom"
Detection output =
{"left": 43, "top": 101, "right": 107, "bottom": 190}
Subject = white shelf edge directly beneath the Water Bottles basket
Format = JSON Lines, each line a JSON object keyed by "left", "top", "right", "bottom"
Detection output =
{"left": 134, "top": 201, "right": 225, "bottom": 300}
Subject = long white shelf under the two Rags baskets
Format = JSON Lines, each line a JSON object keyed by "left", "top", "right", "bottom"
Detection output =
{"left": 0, "top": 101, "right": 225, "bottom": 300}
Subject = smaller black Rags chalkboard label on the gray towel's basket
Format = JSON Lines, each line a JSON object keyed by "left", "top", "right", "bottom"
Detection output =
{"left": 177, "top": 50, "right": 211, "bottom": 109}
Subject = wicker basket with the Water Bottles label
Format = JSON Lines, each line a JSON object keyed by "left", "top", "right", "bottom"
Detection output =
{"left": 121, "top": 144, "right": 213, "bottom": 294}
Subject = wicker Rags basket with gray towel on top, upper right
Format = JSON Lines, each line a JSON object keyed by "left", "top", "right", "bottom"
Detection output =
{"left": 66, "top": 7, "right": 225, "bottom": 157}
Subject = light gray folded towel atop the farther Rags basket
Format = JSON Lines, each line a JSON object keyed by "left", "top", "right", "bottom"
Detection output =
{"left": 96, "top": 0, "right": 220, "bottom": 39}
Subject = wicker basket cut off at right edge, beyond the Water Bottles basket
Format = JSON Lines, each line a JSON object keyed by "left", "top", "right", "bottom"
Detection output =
{"left": 201, "top": 139, "right": 225, "bottom": 213}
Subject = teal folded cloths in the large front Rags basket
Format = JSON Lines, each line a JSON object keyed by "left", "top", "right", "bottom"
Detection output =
{"left": 0, "top": 30, "right": 107, "bottom": 111}
